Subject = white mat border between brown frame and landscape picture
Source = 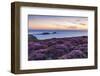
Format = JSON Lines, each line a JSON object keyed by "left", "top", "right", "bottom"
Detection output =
{"left": 20, "top": 6, "right": 95, "bottom": 70}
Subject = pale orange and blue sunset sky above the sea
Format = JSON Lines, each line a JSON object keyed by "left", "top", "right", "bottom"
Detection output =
{"left": 28, "top": 15, "right": 88, "bottom": 30}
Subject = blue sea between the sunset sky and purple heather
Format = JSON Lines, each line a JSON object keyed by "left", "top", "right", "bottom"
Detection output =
{"left": 28, "top": 30, "right": 88, "bottom": 40}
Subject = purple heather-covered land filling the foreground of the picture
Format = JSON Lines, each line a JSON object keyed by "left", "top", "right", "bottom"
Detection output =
{"left": 28, "top": 36, "right": 88, "bottom": 61}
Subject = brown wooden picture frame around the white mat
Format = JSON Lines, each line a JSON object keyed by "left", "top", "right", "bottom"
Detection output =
{"left": 11, "top": 2, "right": 98, "bottom": 74}
